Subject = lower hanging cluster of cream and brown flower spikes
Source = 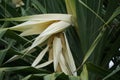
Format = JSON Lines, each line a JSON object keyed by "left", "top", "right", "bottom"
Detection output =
{"left": 31, "top": 32, "right": 77, "bottom": 76}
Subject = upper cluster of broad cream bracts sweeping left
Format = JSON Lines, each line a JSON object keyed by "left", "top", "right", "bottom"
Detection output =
{"left": 10, "top": 14, "right": 72, "bottom": 51}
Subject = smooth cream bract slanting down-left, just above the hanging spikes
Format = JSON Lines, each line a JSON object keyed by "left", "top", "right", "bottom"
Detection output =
{"left": 28, "top": 21, "right": 70, "bottom": 51}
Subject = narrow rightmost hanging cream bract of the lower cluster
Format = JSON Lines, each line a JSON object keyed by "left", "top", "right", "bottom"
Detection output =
{"left": 64, "top": 34, "right": 77, "bottom": 76}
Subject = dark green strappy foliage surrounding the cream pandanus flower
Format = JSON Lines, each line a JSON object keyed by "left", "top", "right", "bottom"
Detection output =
{"left": 0, "top": 0, "right": 120, "bottom": 80}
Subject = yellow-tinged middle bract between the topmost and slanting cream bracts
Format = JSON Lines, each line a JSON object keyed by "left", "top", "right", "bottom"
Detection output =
{"left": 10, "top": 21, "right": 55, "bottom": 36}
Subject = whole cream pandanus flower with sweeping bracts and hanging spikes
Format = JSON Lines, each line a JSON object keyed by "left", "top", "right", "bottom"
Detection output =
{"left": 6, "top": 14, "right": 77, "bottom": 76}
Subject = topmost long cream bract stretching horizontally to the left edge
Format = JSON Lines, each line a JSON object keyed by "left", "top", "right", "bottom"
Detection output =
{"left": 0, "top": 14, "right": 71, "bottom": 23}
